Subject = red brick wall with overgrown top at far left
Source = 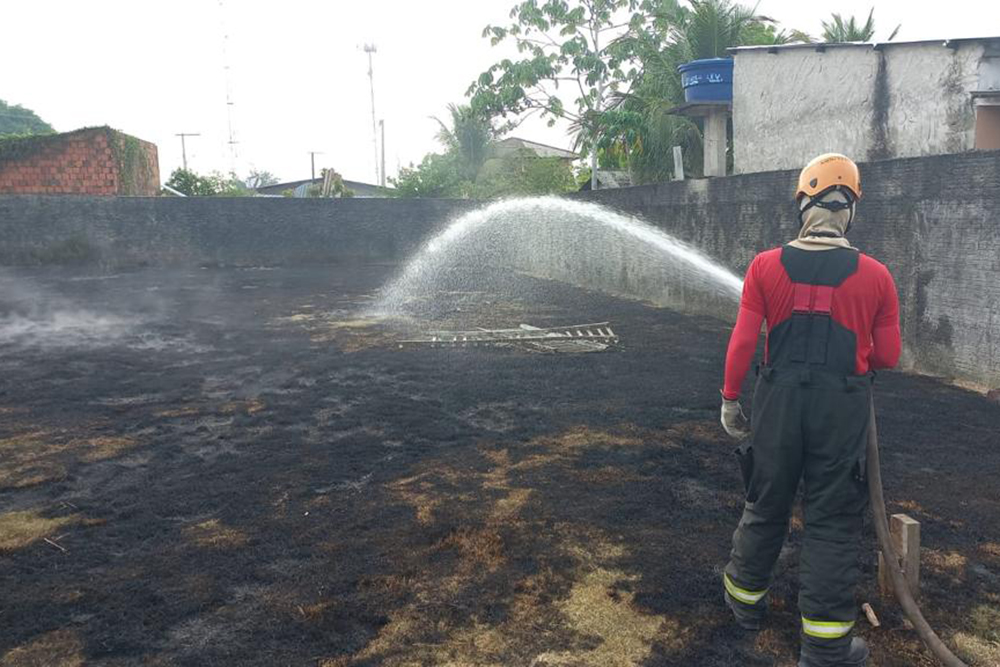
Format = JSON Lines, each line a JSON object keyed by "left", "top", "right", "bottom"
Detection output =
{"left": 0, "top": 127, "right": 160, "bottom": 196}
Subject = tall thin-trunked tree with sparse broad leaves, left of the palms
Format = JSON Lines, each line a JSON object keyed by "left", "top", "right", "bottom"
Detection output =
{"left": 468, "top": 0, "right": 641, "bottom": 189}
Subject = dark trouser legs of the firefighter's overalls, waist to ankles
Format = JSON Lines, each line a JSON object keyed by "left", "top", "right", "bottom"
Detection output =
{"left": 725, "top": 368, "right": 870, "bottom": 643}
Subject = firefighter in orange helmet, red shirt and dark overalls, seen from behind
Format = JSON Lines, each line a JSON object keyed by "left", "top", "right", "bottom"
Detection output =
{"left": 722, "top": 153, "right": 901, "bottom": 667}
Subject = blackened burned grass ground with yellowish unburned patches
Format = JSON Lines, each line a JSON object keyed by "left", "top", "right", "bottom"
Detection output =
{"left": 0, "top": 267, "right": 1000, "bottom": 667}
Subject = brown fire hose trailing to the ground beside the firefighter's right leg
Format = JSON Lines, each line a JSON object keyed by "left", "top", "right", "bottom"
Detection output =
{"left": 868, "top": 400, "right": 968, "bottom": 667}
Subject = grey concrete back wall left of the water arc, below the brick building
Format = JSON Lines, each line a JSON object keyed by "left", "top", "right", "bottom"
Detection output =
{"left": 0, "top": 196, "right": 474, "bottom": 269}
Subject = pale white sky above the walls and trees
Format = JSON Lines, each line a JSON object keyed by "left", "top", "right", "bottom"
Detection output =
{"left": 0, "top": 0, "right": 1000, "bottom": 182}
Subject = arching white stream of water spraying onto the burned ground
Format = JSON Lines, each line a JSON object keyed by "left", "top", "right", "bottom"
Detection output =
{"left": 375, "top": 197, "right": 742, "bottom": 316}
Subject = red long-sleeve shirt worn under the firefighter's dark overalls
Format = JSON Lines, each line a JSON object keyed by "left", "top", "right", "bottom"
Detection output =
{"left": 722, "top": 248, "right": 902, "bottom": 400}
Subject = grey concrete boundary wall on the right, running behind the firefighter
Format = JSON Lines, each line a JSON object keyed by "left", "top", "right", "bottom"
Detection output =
{"left": 586, "top": 152, "right": 1000, "bottom": 387}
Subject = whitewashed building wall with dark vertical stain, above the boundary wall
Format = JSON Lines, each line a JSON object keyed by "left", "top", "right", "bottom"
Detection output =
{"left": 733, "top": 41, "right": 996, "bottom": 173}
